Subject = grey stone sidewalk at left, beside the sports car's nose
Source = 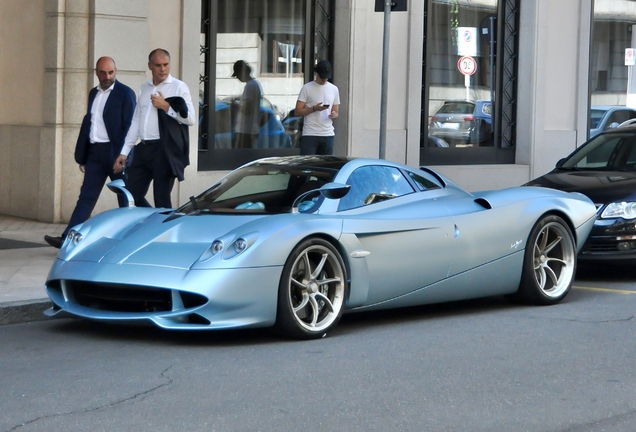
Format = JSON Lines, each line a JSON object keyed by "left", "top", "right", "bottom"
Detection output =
{"left": 0, "top": 215, "right": 66, "bottom": 325}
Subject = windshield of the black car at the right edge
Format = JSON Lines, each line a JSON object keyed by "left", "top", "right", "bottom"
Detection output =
{"left": 560, "top": 131, "right": 636, "bottom": 170}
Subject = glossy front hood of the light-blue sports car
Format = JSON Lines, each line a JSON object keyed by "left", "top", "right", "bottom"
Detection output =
{"left": 58, "top": 209, "right": 271, "bottom": 269}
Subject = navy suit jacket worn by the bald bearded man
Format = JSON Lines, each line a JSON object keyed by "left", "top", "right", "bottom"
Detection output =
{"left": 75, "top": 81, "right": 137, "bottom": 165}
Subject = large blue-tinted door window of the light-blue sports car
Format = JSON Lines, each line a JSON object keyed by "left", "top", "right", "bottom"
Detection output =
{"left": 338, "top": 165, "right": 415, "bottom": 211}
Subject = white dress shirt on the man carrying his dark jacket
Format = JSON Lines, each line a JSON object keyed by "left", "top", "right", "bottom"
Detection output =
{"left": 121, "top": 75, "right": 195, "bottom": 156}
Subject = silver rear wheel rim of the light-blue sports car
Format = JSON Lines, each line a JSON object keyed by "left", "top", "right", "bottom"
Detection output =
{"left": 533, "top": 222, "right": 576, "bottom": 298}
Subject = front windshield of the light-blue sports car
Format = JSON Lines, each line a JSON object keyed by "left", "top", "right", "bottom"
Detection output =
{"left": 176, "top": 157, "right": 346, "bottom": 214}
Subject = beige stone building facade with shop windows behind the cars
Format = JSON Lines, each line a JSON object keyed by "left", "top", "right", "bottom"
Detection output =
{"left": 0, "top": 0, "right": 636, "bottom": 222}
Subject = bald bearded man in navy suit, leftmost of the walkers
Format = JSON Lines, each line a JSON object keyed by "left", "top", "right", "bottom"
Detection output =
{"left": 44, "top": 57, "right": 136, "bottom": 248}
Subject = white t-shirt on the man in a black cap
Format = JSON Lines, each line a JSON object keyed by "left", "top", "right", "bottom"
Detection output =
{"left": 298, "top": 81, "right": 340, "bottom": 136}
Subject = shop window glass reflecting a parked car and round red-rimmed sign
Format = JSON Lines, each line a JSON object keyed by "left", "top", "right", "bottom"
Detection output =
{"left": 422, "top": 0, "right": 497, "bottom": 148}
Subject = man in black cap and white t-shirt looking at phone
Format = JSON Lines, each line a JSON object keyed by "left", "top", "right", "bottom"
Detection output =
{"left": 294, "top": 60, "right": 340, "bottom": 155}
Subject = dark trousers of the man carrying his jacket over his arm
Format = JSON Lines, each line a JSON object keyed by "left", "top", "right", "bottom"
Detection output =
{"left": 126, "top": 140, "right": 175, "bottom": 208}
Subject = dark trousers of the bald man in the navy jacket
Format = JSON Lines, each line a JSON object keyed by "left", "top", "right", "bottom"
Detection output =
{"left": 62, "top": 143, "right": 127, "bottom": 237}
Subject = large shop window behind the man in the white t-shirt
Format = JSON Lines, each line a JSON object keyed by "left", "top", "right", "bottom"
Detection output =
{"left": 199, "top": 0, "right": 334, "bottom": 170}
